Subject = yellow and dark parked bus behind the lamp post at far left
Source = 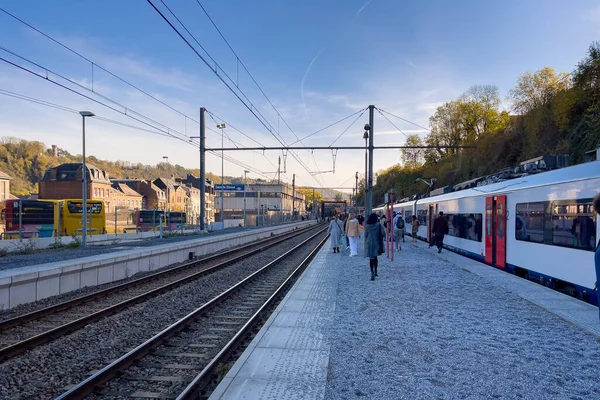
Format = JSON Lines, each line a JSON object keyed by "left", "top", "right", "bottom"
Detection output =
{"left": 4, "top": 199, "right": 106, "bottom": 239}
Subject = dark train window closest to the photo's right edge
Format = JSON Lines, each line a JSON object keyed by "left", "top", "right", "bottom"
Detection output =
{"left": 552, "top": 199, "right": 596, "bottom": 250}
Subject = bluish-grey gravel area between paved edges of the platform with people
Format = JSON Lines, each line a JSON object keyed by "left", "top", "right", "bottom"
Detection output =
{"left": 325, "top": 243, "right": 600, "bottom": 400}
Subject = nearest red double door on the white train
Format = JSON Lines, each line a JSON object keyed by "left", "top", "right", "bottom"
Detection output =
{"left": 485, "top": 196, "right": 506, "bottom": 268}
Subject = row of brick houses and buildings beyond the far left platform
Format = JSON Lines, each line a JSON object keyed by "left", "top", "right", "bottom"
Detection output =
{"left": 38, "top": 163, "right": 306, "bottom": 224}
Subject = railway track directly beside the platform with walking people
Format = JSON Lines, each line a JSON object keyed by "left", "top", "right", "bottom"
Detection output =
{"left": 57, "top": 229, "right": 327, "bottom": 400}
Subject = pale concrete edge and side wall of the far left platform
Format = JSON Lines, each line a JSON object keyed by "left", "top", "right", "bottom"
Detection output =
{"left": 0, "top": 220, "right": 316, "bottom": 310}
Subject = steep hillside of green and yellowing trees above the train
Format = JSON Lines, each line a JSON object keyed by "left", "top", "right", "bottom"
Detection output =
{"left": 358, "top": 42, "right": 600, "bottom": 204}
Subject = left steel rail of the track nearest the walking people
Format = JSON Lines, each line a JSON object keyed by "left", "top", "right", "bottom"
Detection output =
{"left": 55, "top": 228, "right": 327, "bottom": 400}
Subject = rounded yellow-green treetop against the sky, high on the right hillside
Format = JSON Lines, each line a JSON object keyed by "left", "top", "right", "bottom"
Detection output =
{"left": 509, "top": 67, "right": 570, "bottom": 115}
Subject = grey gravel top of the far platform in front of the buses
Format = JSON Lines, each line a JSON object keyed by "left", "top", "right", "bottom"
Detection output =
{"left": 0, "top": 223, "right": 278, "bottom": 271}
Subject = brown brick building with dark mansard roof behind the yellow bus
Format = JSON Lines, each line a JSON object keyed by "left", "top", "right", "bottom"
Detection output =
{"left": 38, "top": 163, "right": 112, "bottom": 203}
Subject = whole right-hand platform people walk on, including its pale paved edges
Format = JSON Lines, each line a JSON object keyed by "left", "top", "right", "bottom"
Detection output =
{"left": 210, "top": 236, "right": 600, "bottom": 400}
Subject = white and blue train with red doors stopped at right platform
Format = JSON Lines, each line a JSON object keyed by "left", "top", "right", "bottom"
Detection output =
{"left": 373, "top": 161, "right": 600, "bottom": 305}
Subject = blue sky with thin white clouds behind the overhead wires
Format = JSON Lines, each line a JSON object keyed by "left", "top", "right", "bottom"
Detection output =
{"left": 0, "top": 0, "right": 600, "bottom": 194}
